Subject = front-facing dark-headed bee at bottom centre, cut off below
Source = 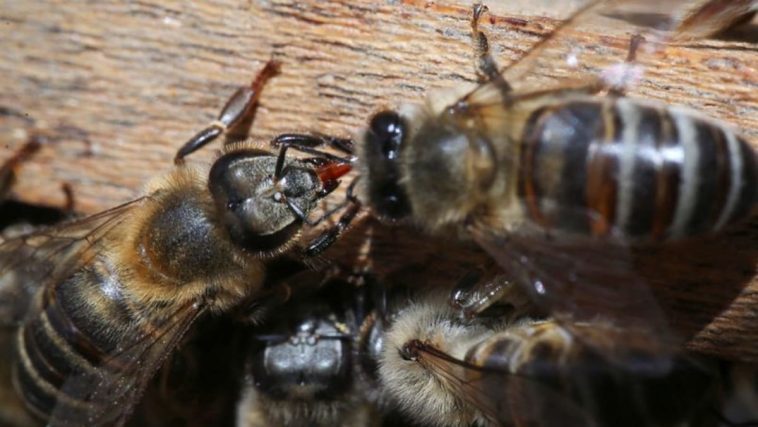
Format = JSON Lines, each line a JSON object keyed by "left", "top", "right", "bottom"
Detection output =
{"left": 238, "top": 279, "right": 384, "bottom": 427}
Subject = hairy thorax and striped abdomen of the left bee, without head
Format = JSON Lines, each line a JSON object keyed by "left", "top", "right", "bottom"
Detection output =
{"left": 15, "top": 171, "right": 263, "bottom": 417}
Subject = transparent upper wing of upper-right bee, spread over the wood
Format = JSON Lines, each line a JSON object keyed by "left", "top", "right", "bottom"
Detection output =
{"left": 451, "top": 0, "right": 758, "bottom": 152}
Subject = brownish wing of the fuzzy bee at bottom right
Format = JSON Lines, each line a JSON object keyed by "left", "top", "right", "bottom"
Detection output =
{"left": 418, "top": 344, "right": 595, "bottom": 426}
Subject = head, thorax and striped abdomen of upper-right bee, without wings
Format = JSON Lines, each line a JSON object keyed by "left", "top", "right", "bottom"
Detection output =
{"left": 366, "top": 93, "right": 758, "bottom": 243}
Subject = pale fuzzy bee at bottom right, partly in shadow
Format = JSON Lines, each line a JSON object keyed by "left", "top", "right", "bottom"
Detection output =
{"left": 379, "top": 284, "right": 732, "bottom": 427}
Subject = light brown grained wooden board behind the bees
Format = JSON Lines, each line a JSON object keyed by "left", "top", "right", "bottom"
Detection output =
{"left": 0, "top": 0, "right": 758, "bottom": 361}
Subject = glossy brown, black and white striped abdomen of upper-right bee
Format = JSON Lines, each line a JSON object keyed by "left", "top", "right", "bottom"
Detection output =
{"left": 518, "top": 98, "right": 756, "bottom": 241}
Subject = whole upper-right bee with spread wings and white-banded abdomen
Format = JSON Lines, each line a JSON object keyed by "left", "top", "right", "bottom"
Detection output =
{"left": 298, "top": 1, "right": 758, "bottom": 358}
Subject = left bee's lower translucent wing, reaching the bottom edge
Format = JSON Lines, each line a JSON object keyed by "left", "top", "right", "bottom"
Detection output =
{"left": 48, "top": 303, "right": 204, "bottom": 427}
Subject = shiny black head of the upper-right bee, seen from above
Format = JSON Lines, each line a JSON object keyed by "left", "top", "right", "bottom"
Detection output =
{"left": 362, "top": 111, "right": 411, "bottom": 220}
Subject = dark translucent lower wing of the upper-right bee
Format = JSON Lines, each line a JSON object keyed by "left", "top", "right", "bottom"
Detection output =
{"left": 472, "top": 224, "right": 680, "bottom": 369}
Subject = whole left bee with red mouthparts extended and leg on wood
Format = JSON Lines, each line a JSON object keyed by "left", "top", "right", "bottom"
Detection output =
{"left": 0, "top": 61, "right": 360, "bottom": 426}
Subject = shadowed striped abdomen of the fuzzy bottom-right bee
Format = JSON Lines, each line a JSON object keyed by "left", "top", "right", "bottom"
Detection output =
{"left": 466, "top": 320, "right": 713, "bottom": 427}
